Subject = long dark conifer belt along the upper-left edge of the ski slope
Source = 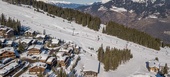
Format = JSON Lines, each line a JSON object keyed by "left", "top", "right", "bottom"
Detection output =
{"left": 5, "top": 0, "right": 101, "bottom": 31}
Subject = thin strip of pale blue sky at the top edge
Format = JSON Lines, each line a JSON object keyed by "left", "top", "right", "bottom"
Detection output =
{"left": 60, "top": 0, "right": 101, "bottom": 4}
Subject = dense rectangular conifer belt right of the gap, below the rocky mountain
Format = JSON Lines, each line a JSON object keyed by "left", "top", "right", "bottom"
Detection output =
{"left": 103, "top": 22, "right": 161, "bottom": 50}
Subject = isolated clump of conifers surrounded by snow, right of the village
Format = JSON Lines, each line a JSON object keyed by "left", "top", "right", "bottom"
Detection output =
{"left": 98, "top": 46, "right": 133, "bottom": 71}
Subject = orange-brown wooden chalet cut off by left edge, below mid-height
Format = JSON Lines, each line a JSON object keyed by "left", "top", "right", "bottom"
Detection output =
{"left": 0, "top": 47, "right": 16, "bottom": 59}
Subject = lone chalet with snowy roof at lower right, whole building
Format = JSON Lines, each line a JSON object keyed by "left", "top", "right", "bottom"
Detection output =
{"left": 148, "top": 60, "right": 160, "bottom": 73}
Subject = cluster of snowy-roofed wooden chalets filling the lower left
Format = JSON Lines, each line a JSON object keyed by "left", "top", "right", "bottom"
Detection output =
{"left": 0, "top": 25, "right": 87, "bottom": 77}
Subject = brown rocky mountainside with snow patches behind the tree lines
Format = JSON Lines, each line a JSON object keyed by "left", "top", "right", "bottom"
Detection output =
{"left": 77, "top": 0, "right": 170, "bottom": 43}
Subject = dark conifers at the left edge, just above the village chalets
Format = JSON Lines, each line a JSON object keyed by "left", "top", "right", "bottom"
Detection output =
{"left": 0, "top": 14, "right": 21, "bottom": 34}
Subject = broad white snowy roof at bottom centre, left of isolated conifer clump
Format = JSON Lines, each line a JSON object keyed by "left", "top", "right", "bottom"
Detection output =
{"left": 83, "top": 59, "right": 99, "bottom": 73}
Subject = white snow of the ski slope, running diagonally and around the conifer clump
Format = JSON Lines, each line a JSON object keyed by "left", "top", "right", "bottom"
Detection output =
{"left": 0, "top": 0, "right": 170, "bottom": 77}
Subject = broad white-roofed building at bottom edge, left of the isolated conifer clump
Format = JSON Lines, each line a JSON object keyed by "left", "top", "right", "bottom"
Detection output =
{"left": 83, "top": 60, "right": 99, "bottom": 77}
